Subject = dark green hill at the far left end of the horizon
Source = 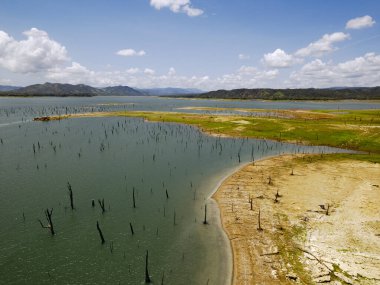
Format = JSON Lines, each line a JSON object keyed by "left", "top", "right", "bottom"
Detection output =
{"left": 0, "top": 83, "right": 104, "bottom": 97}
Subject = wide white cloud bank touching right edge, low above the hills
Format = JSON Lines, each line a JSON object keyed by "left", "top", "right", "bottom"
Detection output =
{"left": 290, "top": 53, "right": 380, "bottom": 87}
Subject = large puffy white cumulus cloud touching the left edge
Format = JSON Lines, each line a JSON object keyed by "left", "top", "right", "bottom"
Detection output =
{"left": 0, "top": 28, "right": 69, "bottom": 73}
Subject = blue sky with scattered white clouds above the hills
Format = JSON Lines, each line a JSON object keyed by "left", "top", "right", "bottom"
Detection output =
{"left": 0, "top": 0, "right": 380, "bottom": 90}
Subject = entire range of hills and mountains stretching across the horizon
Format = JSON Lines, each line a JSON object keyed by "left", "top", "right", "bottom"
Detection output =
{"left": 0, "top": 83, "right": 380, "bottom": 100}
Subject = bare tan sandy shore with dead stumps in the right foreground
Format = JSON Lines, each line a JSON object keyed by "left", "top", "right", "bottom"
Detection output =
{"left": 213, "top": 155, "right": 380, "bottom": 285}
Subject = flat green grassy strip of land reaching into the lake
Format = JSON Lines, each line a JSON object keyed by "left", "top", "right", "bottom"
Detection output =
{"left": 107, "top": 110, "right": 380, "bottom": 154}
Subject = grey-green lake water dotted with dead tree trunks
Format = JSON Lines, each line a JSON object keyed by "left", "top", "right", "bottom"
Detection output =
{"left": 0, "top": 98, "right": 354, "bottom": 284}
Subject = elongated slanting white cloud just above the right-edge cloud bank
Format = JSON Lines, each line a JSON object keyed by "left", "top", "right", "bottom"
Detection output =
{"left": 295, "top": 32, "right": 350, "bottom": 57}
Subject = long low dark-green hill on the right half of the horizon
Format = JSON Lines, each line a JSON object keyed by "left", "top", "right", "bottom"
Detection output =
{"left": 186, "top": 86, "right": 380, "bottom": 100}
